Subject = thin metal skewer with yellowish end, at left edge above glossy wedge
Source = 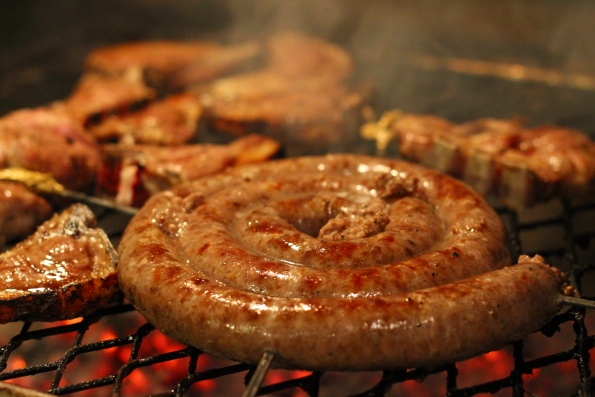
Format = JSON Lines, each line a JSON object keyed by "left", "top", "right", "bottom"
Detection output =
{"left": 0, "top": 168, "right": 138, "bottom": 215}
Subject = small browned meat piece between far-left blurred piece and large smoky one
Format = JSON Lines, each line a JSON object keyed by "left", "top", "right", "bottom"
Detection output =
{"left": 88, "top": 92, "right": 201, "bottom": 145}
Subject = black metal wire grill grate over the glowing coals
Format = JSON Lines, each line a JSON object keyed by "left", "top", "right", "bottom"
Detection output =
{"left": 0, "top": 196, "right": 595, "bottom": 397}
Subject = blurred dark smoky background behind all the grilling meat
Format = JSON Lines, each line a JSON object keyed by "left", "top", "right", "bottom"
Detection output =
{"left": 0, "top": 0, "right": 595, "bottom": 136}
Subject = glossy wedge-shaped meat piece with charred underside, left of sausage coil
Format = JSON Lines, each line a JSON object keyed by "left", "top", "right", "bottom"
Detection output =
{"left": 0, "top": 204, "right": 121, "bottom": 323}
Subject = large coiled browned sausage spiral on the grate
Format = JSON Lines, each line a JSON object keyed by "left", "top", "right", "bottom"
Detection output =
{"left": 119, "top": 155, "right": 561, "bottom": 370}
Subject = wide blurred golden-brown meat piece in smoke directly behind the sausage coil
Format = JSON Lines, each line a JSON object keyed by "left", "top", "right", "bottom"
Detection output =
{"left": 203, "top": 80, "right": 366, "bottom": 147}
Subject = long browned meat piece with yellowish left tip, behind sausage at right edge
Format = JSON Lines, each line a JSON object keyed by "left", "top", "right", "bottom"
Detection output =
{"left": 361, "top": 111, "right": 595, "bottom": 208}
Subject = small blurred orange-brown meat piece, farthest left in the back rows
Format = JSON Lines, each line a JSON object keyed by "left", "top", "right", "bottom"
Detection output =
{"left": 58, "top": 73, "right": 157, "bottom": 124}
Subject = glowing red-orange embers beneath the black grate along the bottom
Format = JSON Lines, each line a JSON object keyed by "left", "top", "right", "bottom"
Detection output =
{"left": 0, "top": 311, "right": 595, "bottom": 397}
